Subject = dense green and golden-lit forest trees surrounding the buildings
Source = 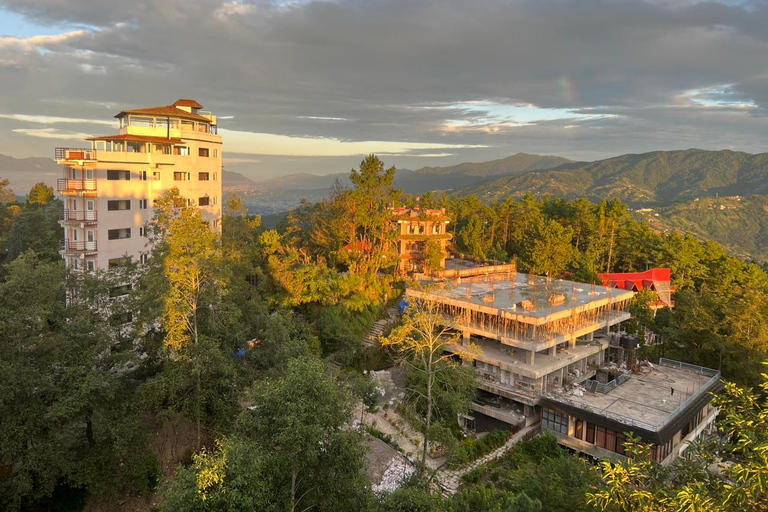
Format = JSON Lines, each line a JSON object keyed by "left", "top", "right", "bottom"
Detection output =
{"left": 0, "top": 159, "right": 768, "bottom": 512}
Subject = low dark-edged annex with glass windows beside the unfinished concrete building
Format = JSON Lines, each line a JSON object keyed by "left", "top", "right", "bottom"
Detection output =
{"left": 539, "top": 358, "right": 723, "bottom": 464}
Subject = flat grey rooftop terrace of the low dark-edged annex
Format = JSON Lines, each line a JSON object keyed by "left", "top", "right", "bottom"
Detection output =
{"left": 542, "top": 358, "right": 722, "bottom": 443}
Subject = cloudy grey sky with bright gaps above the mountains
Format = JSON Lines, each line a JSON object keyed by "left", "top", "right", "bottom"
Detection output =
{"left": 0, "top": 0, "right": 768, "bottom": 179}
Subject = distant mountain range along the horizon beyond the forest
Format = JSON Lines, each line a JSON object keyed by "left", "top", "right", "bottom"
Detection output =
{"left": 0, "top": 149, "right": 768, "bottom": 261}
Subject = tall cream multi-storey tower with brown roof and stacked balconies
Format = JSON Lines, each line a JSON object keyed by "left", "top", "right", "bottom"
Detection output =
{"left": 56, "top": 99, "right": 222, "bottom": 270}
